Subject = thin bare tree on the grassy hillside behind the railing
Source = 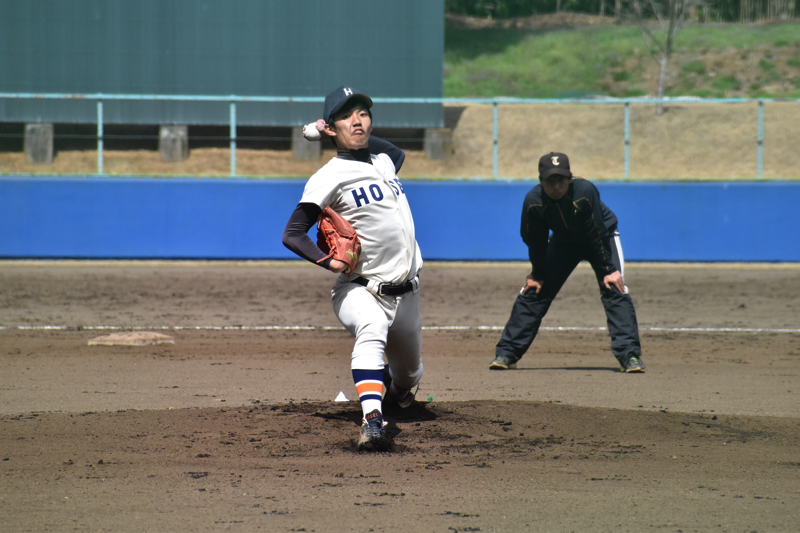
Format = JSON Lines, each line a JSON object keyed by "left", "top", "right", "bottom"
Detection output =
{"left": 627, "top": 0, "right": 705, "bottom": 115}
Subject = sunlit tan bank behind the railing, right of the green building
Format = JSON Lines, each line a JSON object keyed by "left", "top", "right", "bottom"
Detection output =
{"left": 444, "top": 100, "right": 800, "bottom": 180}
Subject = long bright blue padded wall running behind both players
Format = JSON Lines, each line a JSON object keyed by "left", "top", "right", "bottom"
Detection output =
{"left": 0, "top": 176, "right": 800, "bottom": 262}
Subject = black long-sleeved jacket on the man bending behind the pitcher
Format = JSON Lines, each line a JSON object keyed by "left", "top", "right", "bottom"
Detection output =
{"left": 520, "top": 178, "right": 617, "bottom": 279}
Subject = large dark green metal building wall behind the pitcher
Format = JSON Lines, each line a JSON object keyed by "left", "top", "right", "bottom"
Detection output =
{"left": 0, "top": 0, "right": 444, "bottom": 128}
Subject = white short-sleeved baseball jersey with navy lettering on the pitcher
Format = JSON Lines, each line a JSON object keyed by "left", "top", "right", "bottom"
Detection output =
{"left": 300, "top": 154, "right": 422, "bottom": 284}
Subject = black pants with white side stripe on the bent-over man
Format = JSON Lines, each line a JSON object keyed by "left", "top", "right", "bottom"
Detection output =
{"left": 495, "top": 233, "right": 641, "bottom": 365}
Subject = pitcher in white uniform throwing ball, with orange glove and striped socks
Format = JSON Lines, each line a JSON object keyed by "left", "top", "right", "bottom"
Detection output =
{"left": 283, "top": 86, "right": 422, "bottom": 450}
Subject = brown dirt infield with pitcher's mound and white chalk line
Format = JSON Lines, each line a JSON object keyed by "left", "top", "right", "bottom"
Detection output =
{"left": 0, "top": 262, "right": 800, "bottom": 532}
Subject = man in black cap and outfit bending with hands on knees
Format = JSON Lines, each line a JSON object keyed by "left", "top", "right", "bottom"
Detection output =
{"left": 489, "top": 152, "right": 644, "bottom": 372}
